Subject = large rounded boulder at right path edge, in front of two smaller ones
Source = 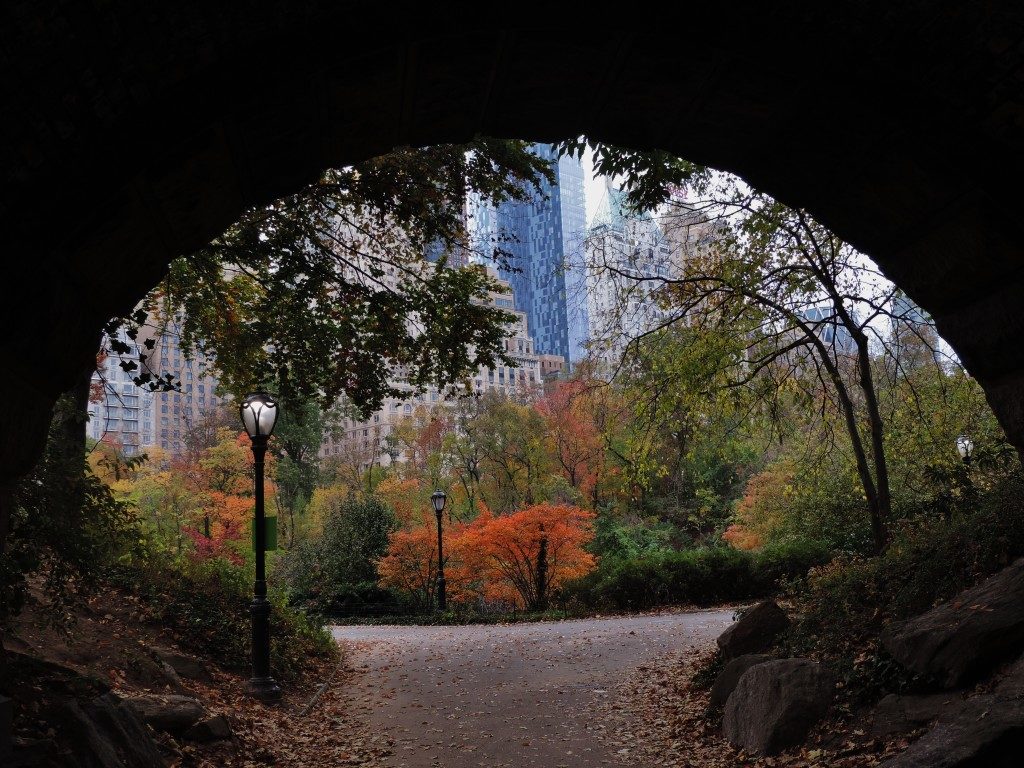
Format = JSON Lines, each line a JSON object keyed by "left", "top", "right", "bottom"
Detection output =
{"left": 722, "top": 658, "right": 836, "bottom": 755}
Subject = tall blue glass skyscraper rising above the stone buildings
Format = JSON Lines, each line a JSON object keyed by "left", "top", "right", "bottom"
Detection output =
{"left": 487, "top": 144, "right": 589, "bottom": 365}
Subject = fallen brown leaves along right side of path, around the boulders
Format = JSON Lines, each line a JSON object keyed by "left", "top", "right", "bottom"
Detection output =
{"left": 602, "top": 649, "right": 907, "bottom": 768}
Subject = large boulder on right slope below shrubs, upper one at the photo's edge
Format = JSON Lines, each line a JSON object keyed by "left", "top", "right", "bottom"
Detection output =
{"left": 882, "top": 558, "right": 1024, "bottom": 688}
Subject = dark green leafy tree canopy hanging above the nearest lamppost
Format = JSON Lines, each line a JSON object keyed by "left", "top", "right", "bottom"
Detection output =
{"left": 109, "top": 138, "right": 551, "bottom": 410}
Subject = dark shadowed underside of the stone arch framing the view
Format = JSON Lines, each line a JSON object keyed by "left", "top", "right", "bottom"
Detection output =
{"left": 6, "top": 0, "right": 1024, "bottom": 493}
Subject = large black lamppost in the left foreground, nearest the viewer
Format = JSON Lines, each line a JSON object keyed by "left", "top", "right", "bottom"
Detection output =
{"left": 239, "top": 392, "right": 281, "bottom": 701}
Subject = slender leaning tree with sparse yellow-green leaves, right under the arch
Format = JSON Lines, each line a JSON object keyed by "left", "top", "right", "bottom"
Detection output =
{"left": 592, "top": 169, "right": 946, "bottom": 551}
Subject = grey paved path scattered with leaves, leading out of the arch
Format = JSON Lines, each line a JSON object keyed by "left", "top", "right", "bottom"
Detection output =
{"left": 333, "top": 610, "right": 732, "bottom": 768}
